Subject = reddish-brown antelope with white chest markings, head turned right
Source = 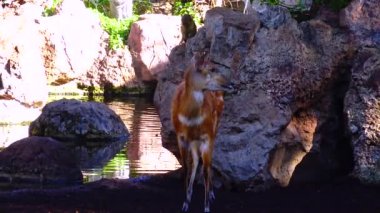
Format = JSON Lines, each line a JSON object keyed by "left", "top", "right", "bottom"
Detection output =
{"left": 171, "top": 52, "right": 227, "bottom": 212}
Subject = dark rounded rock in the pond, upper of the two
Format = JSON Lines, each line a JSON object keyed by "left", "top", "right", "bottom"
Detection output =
{"left": 29, "top": 99, "right": 128, "bottom": 145}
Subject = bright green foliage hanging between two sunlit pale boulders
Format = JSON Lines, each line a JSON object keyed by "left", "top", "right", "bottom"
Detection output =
{"left": 84, "top": 0, "right": 138, "bottom": 49}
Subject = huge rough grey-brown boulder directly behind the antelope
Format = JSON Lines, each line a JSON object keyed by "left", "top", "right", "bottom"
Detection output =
{"left": 155, "top": 8, "right": 352, "bottom": 189}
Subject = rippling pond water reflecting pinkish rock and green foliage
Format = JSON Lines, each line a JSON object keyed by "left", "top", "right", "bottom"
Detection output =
{"left": 0, "top": 98, "right": 180, "bottom": 182}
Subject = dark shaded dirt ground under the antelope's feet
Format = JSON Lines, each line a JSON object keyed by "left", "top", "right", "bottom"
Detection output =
{"left": 0, "top": 172, "right": 380, "bottom": 213}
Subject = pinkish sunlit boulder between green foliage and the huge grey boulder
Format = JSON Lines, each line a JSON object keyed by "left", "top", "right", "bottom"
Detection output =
{"left": 128, "top": 14, "right": 181, "bottom": 81}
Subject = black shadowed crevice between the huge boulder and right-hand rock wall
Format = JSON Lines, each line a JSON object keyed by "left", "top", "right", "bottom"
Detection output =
{"left": 291, "top": 58, "right": 354, "bottom": 183}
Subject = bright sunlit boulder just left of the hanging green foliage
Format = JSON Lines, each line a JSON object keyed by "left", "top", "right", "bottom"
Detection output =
{"left": 40, "top": 0, "right": 105, "bottom": 85}
